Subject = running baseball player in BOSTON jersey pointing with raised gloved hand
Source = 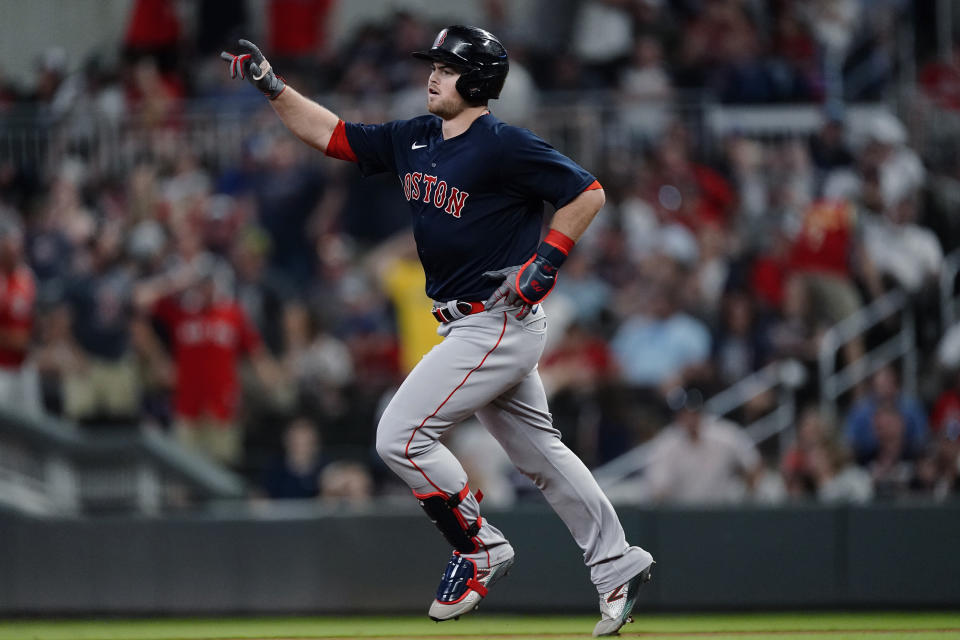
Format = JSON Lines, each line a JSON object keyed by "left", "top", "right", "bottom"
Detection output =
{"left": 221, "top": 25, "right": 654, "bottom": 636}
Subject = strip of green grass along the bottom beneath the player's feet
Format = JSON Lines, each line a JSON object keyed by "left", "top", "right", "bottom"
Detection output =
{"left": 0, "top": 612, "right": 960, "bottom": 640}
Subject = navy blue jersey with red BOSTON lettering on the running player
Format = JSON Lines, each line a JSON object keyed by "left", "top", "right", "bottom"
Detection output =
{"left": 344, "top": 114, "right": 595, "bottom": 302}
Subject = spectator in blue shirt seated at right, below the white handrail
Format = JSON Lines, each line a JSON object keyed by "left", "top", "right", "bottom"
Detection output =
{"left": 844, "top": 366, "right": 927, "bottom": 464}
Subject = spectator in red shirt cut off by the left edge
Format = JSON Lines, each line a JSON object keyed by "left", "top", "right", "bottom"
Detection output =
{"left": 0, "top": 220, "right": 41, "bottom": 414}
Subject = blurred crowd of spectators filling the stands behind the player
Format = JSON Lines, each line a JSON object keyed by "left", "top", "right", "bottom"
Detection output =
{"left": 0, "top": 0, "right": 960, "bottom": 510}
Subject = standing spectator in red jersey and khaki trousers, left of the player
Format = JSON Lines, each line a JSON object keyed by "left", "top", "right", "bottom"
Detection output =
{"left": 137, "top": 254, "right": 283, "bottom": 466}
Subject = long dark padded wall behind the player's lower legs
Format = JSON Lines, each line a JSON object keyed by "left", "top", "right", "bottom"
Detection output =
{"left": 0, "top": 506, "right": 960, "bottom": 614}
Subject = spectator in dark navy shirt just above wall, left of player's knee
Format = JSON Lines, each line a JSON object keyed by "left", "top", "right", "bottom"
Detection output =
{"left": 262, "top": 418, "right": 330, "bottom": 499}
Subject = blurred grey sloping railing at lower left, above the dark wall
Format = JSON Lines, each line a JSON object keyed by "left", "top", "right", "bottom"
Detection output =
{"left": 0, "top": 409, "right": 245, "bottom": 515}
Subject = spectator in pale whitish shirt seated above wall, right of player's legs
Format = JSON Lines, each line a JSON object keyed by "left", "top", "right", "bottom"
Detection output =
{"left": 646, "top": 389, "right": 763, "bottom": 503}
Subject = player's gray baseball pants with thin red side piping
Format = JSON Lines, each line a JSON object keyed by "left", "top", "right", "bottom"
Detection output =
{"left": 377, "top": 305, "right": 652, "bottom": 593}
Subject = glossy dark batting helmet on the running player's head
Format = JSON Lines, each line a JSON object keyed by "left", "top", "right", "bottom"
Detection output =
{"left": 413, "top": 24, "right": 510, "bottom": 103}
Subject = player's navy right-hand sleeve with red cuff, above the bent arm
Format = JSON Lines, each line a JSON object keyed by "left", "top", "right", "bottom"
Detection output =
{"left": 500, "top": 127, "right": 600, "bottom": 209}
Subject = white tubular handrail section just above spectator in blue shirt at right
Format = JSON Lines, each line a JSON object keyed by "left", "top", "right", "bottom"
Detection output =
{"left": 817, "top": 289, "right": 917, "bottom": 417}
